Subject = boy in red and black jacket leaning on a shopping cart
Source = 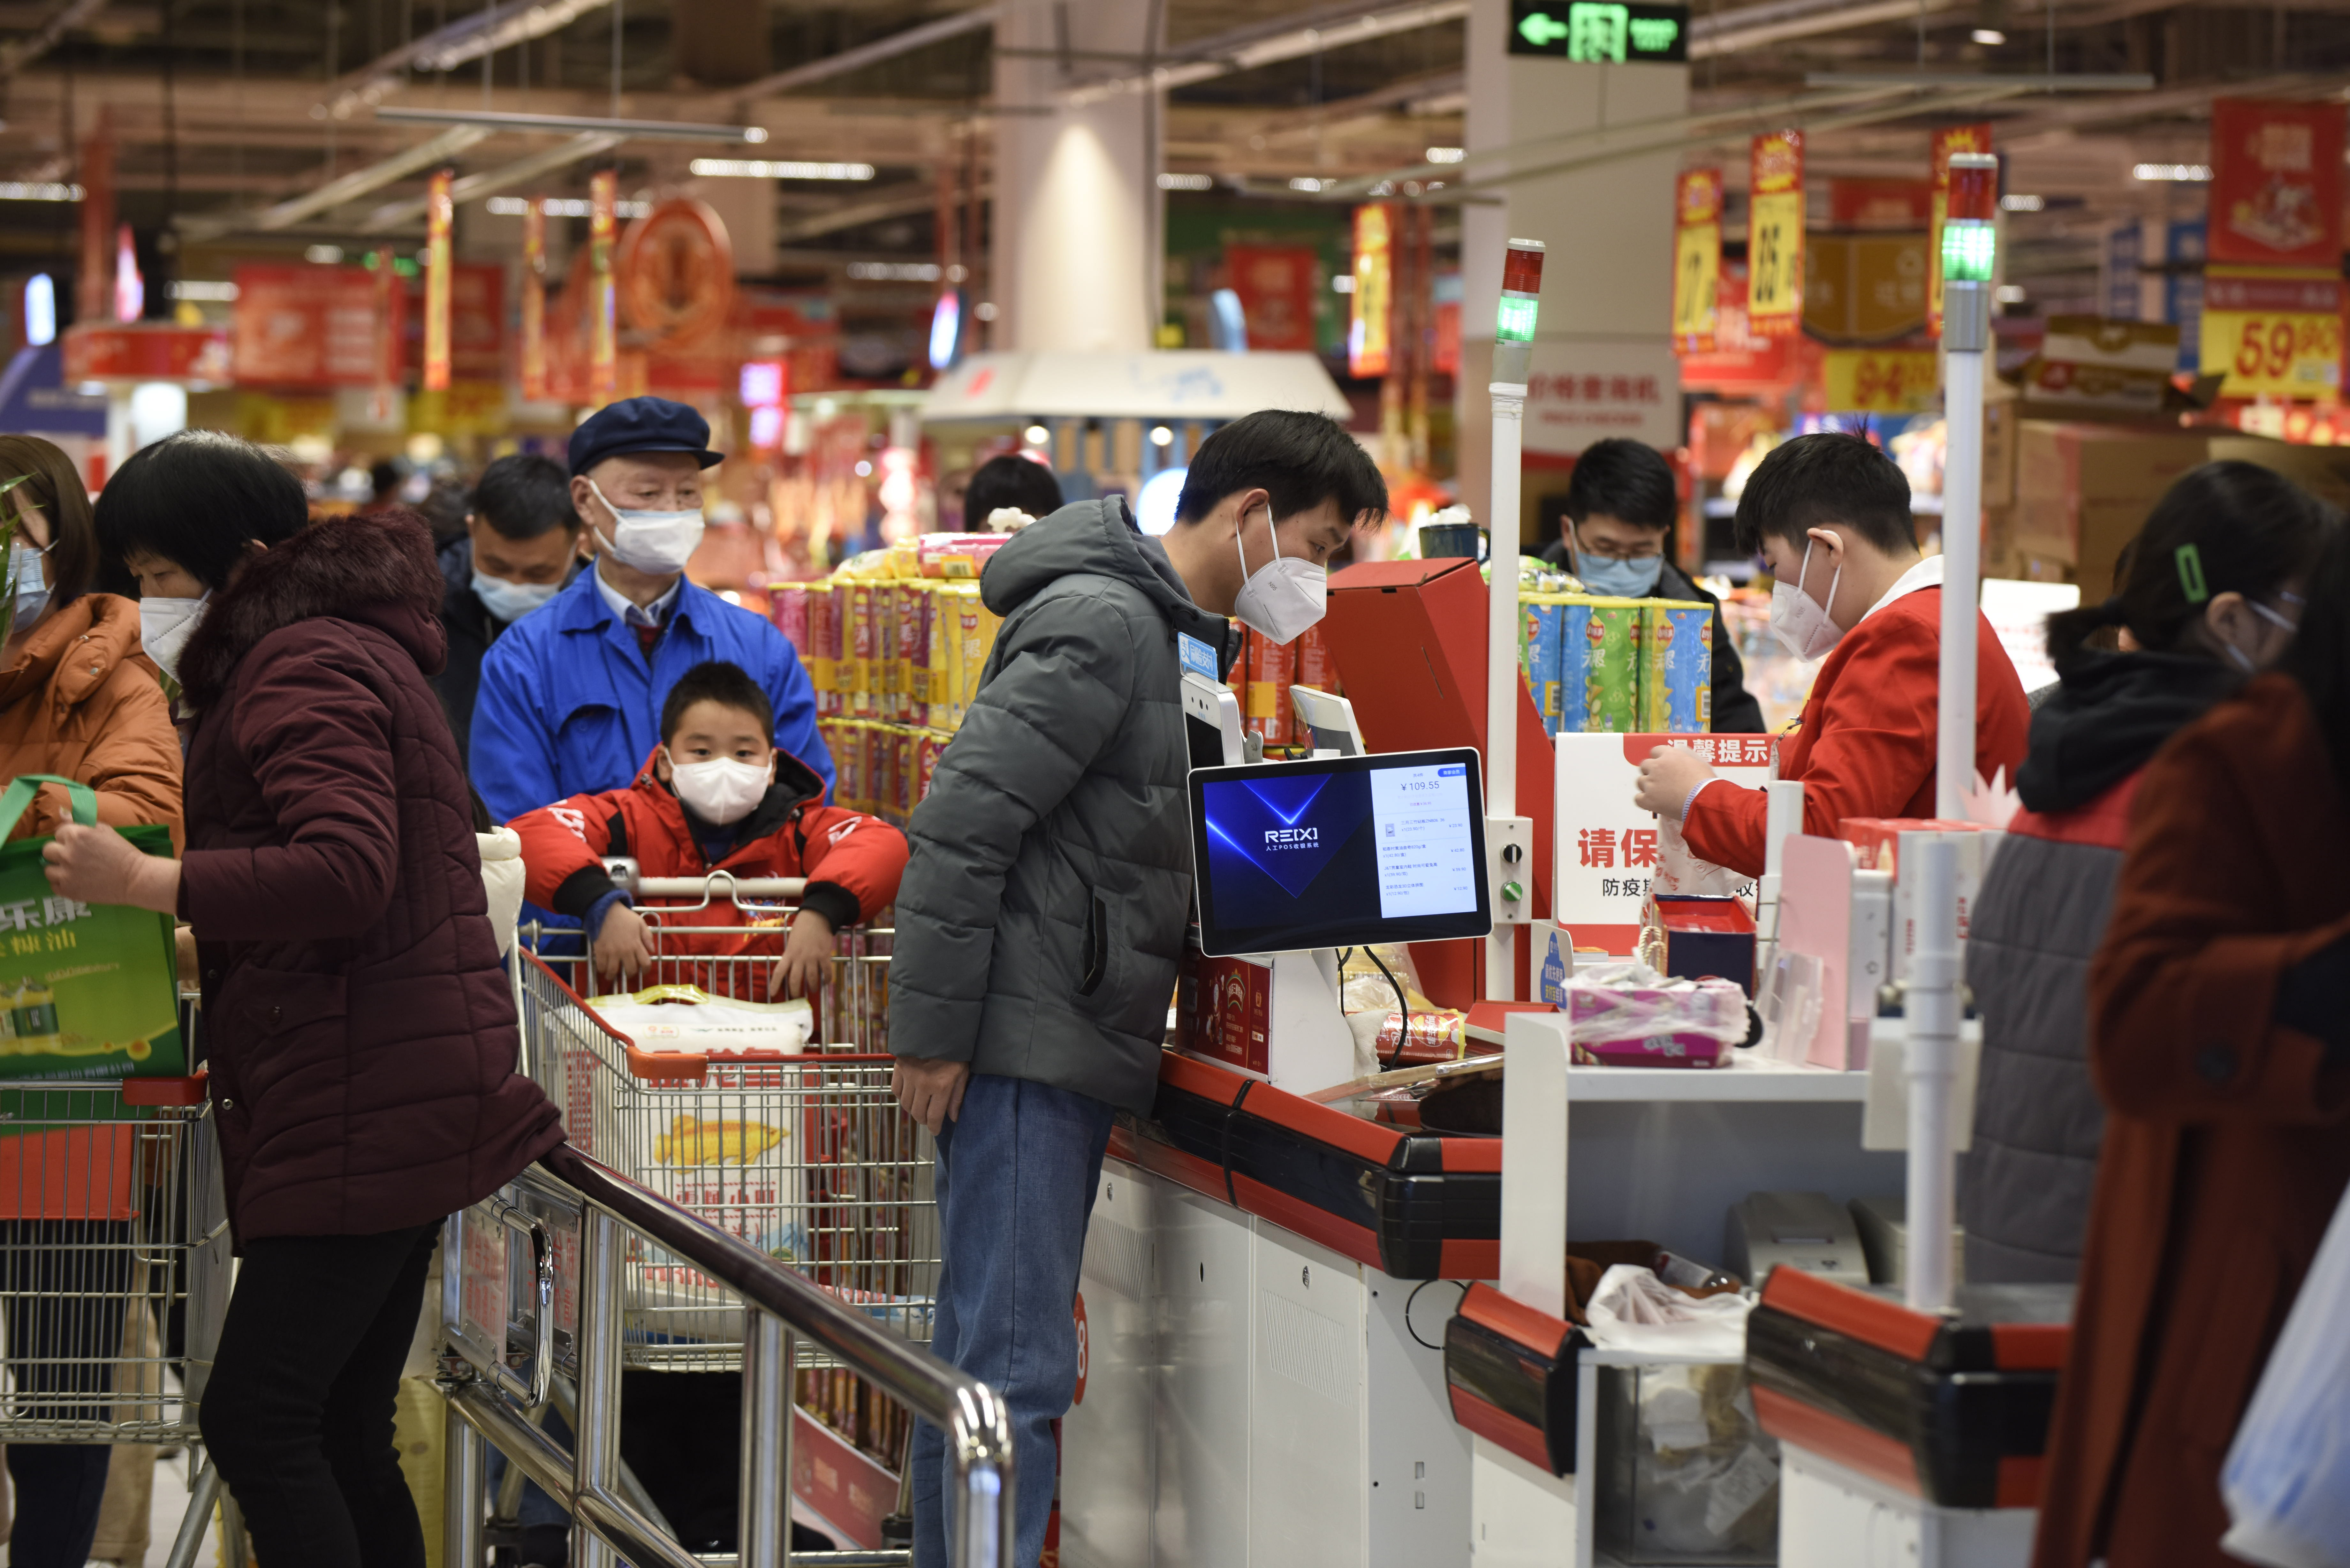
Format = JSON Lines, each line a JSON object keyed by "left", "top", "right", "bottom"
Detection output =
{"left": 512, "top": 660, "right": 905, "bottom": 997}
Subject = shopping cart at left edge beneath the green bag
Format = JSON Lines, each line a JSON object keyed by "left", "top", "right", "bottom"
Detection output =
{"left": 0, "top": 1074, "right": 230, "bottom": 1568}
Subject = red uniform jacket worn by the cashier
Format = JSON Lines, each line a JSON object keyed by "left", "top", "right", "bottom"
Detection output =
{"left": 1680, "top": 588, "right": 2033, "bottom": 877}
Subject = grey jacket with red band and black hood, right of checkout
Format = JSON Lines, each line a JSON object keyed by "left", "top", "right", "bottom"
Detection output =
{"left": 1958, "top": 653, "right": 2237, "bottom": 1284}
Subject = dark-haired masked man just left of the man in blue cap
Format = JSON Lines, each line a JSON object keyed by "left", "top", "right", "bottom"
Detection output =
{"left": 432, "top": 454, "right": 580, "bottom": 771}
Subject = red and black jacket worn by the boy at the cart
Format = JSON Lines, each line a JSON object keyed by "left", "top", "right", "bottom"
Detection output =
{"left": 512, "top": 750, "right": 905, "bottom": 994}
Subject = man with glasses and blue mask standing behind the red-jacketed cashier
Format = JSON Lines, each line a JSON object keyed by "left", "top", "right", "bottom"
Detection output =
{"left": 1542, "top": 435, "right": 1762, "bottom": 736}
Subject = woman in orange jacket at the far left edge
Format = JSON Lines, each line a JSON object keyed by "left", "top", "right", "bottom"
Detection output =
{"left": 0, "top": 435, "right": 178, "bottom": 1568}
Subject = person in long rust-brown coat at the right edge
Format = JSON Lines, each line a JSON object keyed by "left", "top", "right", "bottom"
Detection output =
{"left": 2033, "top": 527, "right": 2350, "bottom": 1568}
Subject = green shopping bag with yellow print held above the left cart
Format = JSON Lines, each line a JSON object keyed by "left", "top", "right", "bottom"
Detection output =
{"left": 0, "top": 773, "right": 188, "bottom": 1082}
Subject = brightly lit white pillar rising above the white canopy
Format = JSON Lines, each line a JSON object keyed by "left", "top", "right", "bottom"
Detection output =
{"left": 987, "top": 0, "right": 1161, "bottom": 353}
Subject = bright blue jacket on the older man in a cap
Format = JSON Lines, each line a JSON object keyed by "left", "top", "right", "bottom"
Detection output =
{"left": 470, "top": 571, "right": 832, "bottom": 823}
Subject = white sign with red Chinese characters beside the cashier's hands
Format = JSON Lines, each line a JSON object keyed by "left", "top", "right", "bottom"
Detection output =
{"left": 1551, "top": 734, "right": 1777, "bottom": 954}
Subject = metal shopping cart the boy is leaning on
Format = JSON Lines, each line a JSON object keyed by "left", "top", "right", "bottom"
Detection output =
{"left": 505, "top": 879, "right": 940, "bottom": 1544}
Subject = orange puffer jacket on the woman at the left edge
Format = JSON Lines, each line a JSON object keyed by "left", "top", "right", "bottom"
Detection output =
{"left": 0, "top": 592, "right": 181, "bottom": 849}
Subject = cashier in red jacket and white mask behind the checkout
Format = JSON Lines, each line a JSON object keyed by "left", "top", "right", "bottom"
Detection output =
{"left": 1633, "top": 435, "right": 2030, "bottom": 877}
